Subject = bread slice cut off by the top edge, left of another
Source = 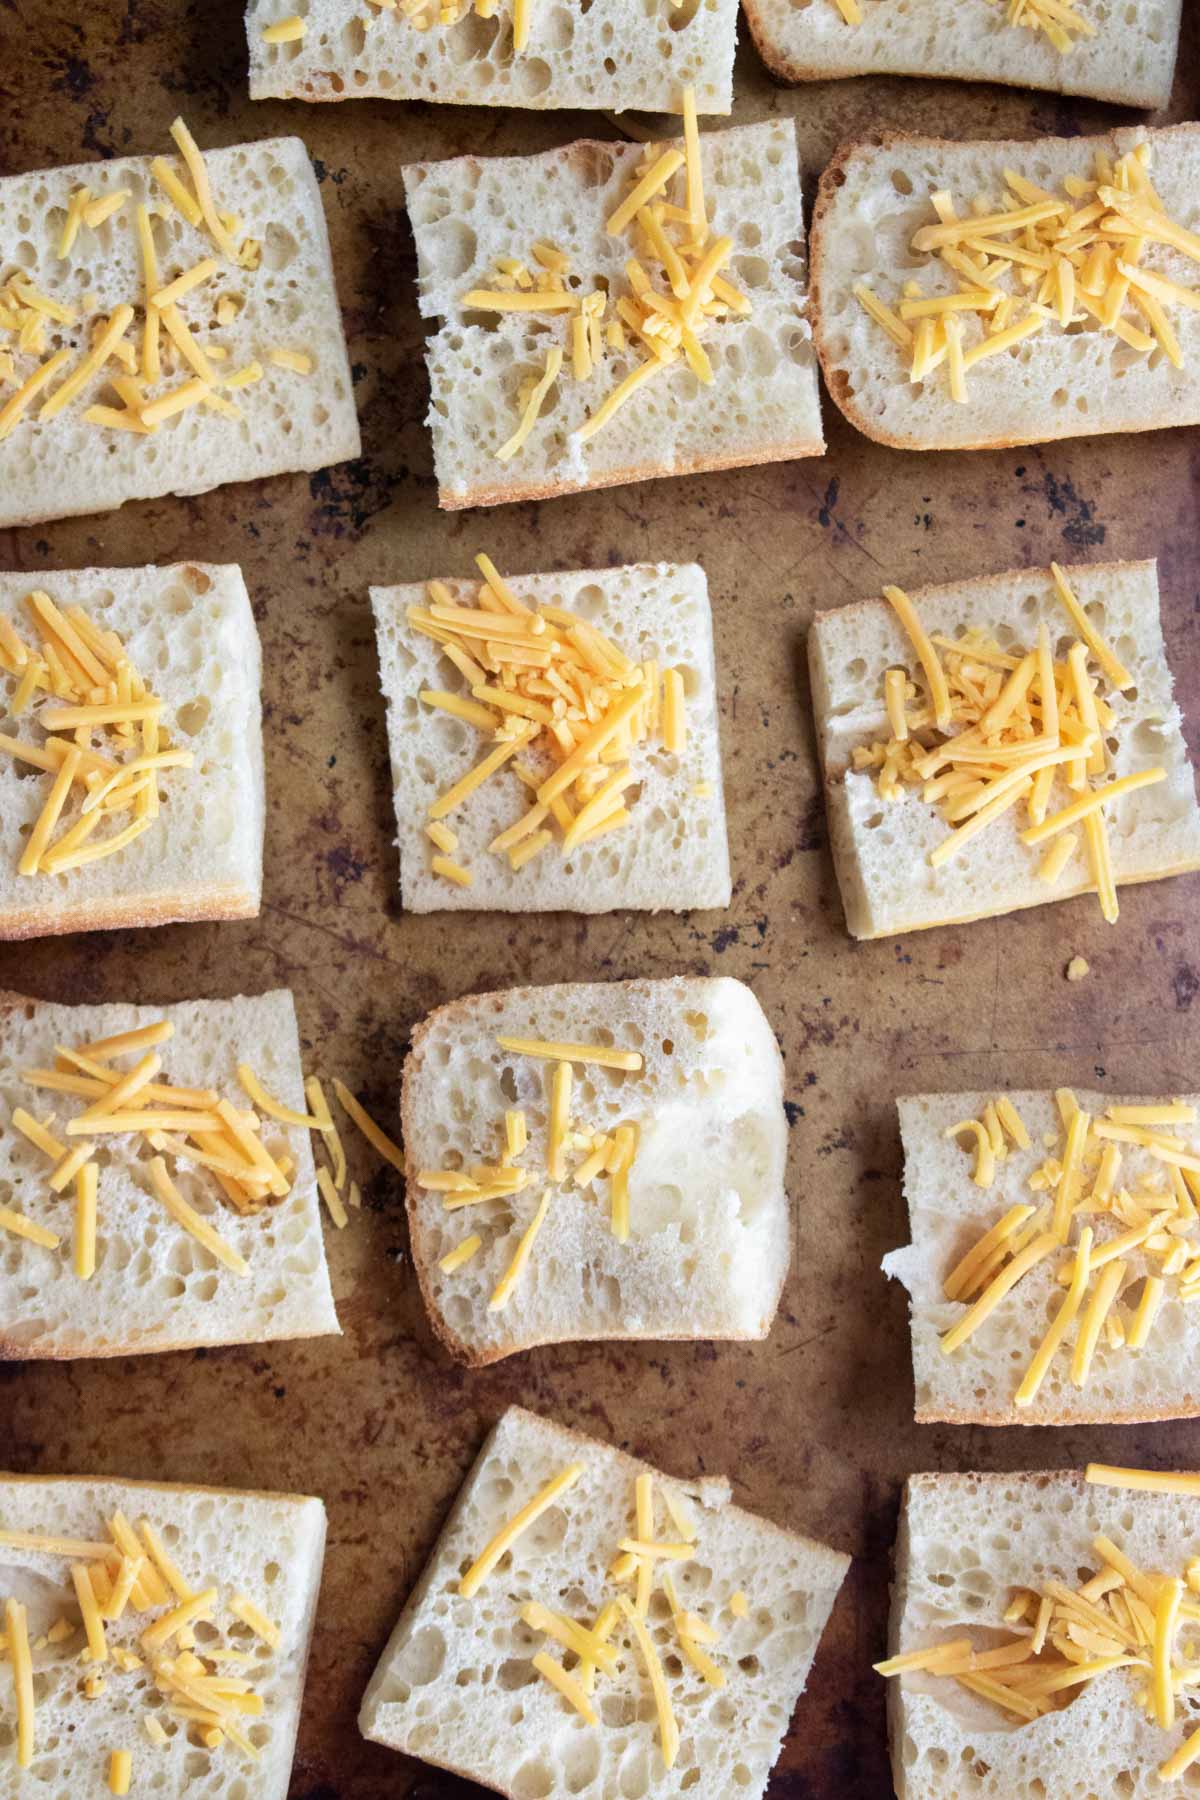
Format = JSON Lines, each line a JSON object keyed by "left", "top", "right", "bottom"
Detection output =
{"left": 246, "top": 0, "right": 738, "bottom": 113}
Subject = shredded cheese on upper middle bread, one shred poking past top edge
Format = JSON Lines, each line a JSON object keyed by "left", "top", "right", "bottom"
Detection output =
{"left": 462, "top": 88, "right": 750, "bottom": 463}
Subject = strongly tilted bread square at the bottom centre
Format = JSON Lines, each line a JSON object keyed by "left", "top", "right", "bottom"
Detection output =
{"left": 358, "top": 1406, "right": 849, "bottom": 1800}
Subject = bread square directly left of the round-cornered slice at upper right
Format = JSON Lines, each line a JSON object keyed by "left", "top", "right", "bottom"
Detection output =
{"left": 403, "top": 119, "right": 824, "bottom": 508}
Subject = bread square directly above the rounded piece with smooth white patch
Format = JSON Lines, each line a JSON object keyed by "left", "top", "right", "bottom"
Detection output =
{"left": 371, "top": 563, "right": 730, "bottom": 913}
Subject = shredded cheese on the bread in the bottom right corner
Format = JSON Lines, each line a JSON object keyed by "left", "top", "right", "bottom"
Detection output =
{"left": 874, "top": 1463, "right": 1200, "bottom": 1782}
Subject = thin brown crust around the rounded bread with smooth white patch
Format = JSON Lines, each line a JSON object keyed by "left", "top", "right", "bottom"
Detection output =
{"left": 399, "top": 977, "right": 790, "bottom": 1368}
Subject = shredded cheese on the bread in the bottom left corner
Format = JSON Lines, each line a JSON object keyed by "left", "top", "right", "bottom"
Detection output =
{"left": 0, "top": 1512, "right": 281, "bottom": 1771}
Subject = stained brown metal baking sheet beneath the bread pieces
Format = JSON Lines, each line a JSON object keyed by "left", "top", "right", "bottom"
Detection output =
{"left": 0, "top": 0, "right": 1200, "bottom": 1800}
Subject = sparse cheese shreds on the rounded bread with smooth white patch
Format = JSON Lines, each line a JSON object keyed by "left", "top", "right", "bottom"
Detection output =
{"left": 424, "top": 1037, "right": 642, "bottom": 1312}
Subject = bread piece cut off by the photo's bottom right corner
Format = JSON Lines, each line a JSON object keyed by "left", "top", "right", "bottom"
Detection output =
{"left": 887, "top": 1471, "right": 1200, "bottom": 1800}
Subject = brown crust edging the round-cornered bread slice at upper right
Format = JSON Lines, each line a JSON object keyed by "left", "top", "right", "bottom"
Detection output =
{"left": 808, "top": 122, "right": 1200, "bottom": 450}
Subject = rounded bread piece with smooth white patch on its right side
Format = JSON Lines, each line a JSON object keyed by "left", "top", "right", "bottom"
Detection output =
{"left": 403, "top": 977, "right": 790, "bottom": 1366}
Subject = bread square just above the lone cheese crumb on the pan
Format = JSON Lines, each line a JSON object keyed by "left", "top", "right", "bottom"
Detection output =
{"left": 808, "top": 562, "right": 1200, "bottom": 938}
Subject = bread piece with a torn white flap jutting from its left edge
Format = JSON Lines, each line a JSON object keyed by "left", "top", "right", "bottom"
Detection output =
{"left": 883, "top": 1089, "right": 1200, "bottom": 1426}
